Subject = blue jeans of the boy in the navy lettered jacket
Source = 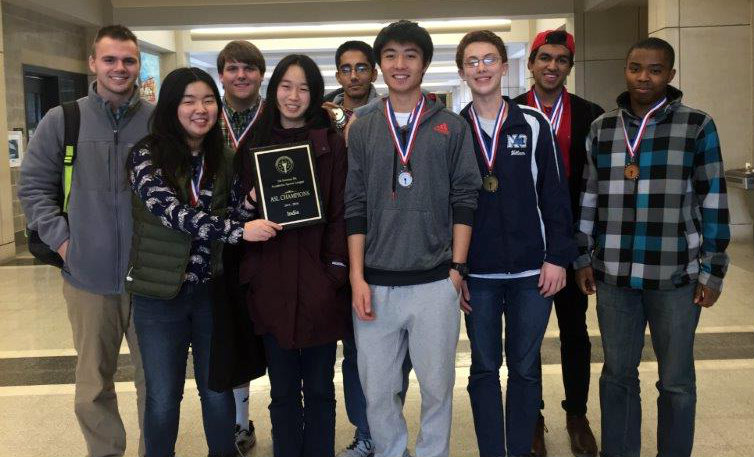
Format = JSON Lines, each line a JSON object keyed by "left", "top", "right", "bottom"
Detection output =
{"left": 466, "top": 275, "right": 552, "bottom": 457}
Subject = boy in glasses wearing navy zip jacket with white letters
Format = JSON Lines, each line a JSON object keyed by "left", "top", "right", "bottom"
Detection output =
{"left": 456, "top": 30, "right": 576, "bottom": 456}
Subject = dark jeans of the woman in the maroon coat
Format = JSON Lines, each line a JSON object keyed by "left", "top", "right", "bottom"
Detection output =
{"left": 264, "top": 334, "right": 336, "bottom": 457}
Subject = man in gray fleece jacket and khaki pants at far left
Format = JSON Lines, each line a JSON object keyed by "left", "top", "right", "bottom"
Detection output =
{"left": 18, "top": 25, "right": 154, "bottom": 457}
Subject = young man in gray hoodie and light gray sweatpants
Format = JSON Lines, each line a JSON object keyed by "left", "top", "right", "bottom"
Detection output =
{"left": 346, "top": 21, "right": 481, "bottom": 457}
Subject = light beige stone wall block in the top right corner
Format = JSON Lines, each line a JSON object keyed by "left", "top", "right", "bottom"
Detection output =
{"left": 680, "top": 0, "right": 751, "bottom": 27}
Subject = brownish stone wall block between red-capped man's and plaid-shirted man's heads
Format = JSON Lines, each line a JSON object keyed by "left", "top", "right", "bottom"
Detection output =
{"left": 583, "top": 8, "right": 639, "bottom": 60}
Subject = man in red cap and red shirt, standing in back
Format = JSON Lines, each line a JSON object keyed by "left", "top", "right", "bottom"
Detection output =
{"left": 514, "top": 30, "right": 604, "bottom": 457}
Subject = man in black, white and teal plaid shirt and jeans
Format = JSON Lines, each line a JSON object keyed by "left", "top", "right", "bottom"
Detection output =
{"left": 574, "top": 38, "right": 730, "bottom": 457}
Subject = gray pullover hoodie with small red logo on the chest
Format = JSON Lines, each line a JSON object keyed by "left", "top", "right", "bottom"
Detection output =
{"left": 345, "top": 96, "right": 482, "bottom": 286}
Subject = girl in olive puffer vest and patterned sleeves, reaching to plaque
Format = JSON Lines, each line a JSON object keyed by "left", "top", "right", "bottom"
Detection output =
{"left": 123, "top": 68, "right": 279, "bottom": 456}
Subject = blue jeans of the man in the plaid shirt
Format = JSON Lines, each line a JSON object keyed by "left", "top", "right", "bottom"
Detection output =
{"left": 597, "top": 282, "right": 701, "bottom": 457}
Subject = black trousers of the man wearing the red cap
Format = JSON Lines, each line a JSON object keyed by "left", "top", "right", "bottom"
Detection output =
{"left": 539, "top": 268, "right": 592, "bottom": 416}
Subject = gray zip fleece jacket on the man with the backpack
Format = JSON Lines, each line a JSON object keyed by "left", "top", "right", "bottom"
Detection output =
{"left": 18, "top": 83, "right": 154, "bottom": 295}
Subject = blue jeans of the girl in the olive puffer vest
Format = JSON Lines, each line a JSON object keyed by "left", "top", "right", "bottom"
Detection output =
{"left": 132, "top": 284, "right": 235, "bottom": 457}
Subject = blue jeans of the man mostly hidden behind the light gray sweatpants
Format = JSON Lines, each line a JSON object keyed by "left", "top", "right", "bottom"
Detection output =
{"left": 341, "top": 336, "right": 411, "bottom": 440}
